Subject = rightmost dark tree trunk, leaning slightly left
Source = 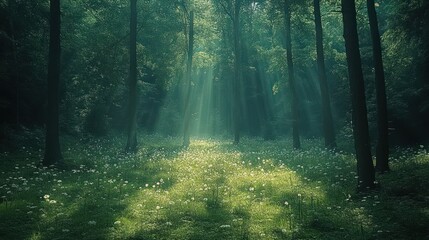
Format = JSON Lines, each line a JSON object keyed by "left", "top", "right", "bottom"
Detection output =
{"left": 367, "top": 0, "right": 389, "bottom": 172}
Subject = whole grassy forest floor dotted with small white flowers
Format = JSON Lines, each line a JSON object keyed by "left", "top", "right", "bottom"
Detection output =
{"left": 0, "top": 136, "right": 429, "bottom": 239}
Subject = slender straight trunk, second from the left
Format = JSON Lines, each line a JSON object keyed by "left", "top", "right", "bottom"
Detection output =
{"left": 125, "top": 0, "right": 137, "bottom": 152}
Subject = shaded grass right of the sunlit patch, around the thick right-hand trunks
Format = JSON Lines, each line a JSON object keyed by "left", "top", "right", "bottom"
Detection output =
{"left": 225, "top": 140, "right": 429, "bottom": 239}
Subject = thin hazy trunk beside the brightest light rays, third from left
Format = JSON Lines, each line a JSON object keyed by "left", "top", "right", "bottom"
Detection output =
{"left": 183, "top": 11, "right": 194, "bottom": 147}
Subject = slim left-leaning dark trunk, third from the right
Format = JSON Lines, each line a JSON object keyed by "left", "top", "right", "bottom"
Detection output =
{"left": 314, "top": 0, "right": 336, "bottom": 149}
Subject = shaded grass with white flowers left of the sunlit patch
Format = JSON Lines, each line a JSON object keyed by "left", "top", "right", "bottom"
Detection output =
{"left": 0, "top": 136, "right": 184, "bottom": 239}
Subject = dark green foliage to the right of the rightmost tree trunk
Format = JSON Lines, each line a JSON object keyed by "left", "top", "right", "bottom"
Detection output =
{"left": 380, "top": 1, "right": 429, "bottom": 144}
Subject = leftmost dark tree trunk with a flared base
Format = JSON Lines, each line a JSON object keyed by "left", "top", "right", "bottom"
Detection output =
{"left": 43, "top": 0, "right": 63, "bottom": 166}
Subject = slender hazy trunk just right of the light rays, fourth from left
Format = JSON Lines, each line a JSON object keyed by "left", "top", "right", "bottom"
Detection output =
{"left": 232, "top": 0, "right": 242, "bottom": 144}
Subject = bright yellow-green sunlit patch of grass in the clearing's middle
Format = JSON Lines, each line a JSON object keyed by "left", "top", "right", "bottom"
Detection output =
{"left": 104, "top": 136, "right": 334, "bottom": 238}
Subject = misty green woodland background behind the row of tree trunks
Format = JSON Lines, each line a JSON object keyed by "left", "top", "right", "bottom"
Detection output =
{"left": 0, "top": 0, "right": 429, "bottom": 151}
